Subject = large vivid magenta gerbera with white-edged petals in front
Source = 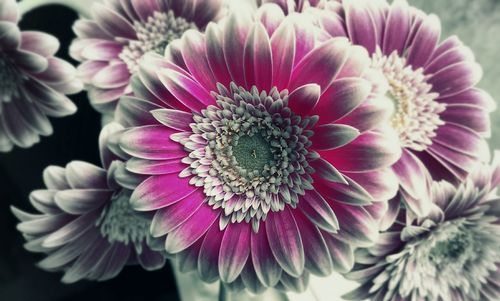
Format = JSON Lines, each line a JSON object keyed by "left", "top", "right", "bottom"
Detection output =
{"left": 116, "top": 4, "right": 401, "bottom": 292}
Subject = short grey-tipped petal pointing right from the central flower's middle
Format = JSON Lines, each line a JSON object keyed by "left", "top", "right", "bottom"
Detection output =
{"left": 311, "top": 124, "right": 359, "bottom": 150}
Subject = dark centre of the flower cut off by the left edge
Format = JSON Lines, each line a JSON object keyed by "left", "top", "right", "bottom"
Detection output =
{"left": 0, "top": 50, "right": 24, "bottom": 104}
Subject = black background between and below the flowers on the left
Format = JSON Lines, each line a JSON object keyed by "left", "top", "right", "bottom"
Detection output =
{"left": 0, "top": 4, "right": 179, "bottom": 301}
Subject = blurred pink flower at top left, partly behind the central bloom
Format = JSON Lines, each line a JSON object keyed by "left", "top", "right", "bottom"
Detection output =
{"left": 71, "top": 0, "right": 223, "bottom": 113}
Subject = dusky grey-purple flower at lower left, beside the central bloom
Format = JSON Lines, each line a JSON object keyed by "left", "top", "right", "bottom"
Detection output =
{"left": 12, "top": 124, "right": 165, "bottom": 283}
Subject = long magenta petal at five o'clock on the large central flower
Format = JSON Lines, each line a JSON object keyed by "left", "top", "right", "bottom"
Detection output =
{"left": 295, "top": 211, "right": 333, "bottom": 276}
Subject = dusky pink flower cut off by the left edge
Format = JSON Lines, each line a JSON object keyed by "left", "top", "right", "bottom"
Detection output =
{"left": 0, "top": 0, "right": 82, "bottom": 152}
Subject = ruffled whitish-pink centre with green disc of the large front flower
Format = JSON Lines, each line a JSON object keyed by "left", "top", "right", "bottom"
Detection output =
{"left": 176, "top": 84, "right": 318, "bottom": 232}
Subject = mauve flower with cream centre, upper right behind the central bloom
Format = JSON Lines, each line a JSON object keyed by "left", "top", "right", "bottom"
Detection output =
{"left": 308, "top": 0, "right": 495, "bottom": 216}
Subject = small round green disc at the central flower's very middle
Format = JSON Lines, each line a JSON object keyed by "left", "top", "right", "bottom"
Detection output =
{"left": 232, "top": 134, "right": 274, "bottom": 170}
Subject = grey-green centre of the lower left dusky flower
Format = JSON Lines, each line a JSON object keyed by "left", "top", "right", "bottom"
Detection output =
{"left": 96, "top": 191, "right": 150, "bottom": 246}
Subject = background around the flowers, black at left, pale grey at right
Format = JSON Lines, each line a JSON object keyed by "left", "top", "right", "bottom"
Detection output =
{"left": 0, "top": 0, "right": 500, "bottom": 301}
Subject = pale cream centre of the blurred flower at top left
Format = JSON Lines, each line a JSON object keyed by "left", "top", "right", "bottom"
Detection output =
{"left": 119, "top": 10, "right": 198, "bottom": 73}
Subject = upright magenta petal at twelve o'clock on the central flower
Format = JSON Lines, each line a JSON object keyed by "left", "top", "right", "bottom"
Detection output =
{"left": 243, "top": 23, "right": 273, "bottom": 91}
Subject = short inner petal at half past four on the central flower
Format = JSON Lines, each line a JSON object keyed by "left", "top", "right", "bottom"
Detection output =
{"left": 298, "top": 190, "right": 339, "bottom": 233}
